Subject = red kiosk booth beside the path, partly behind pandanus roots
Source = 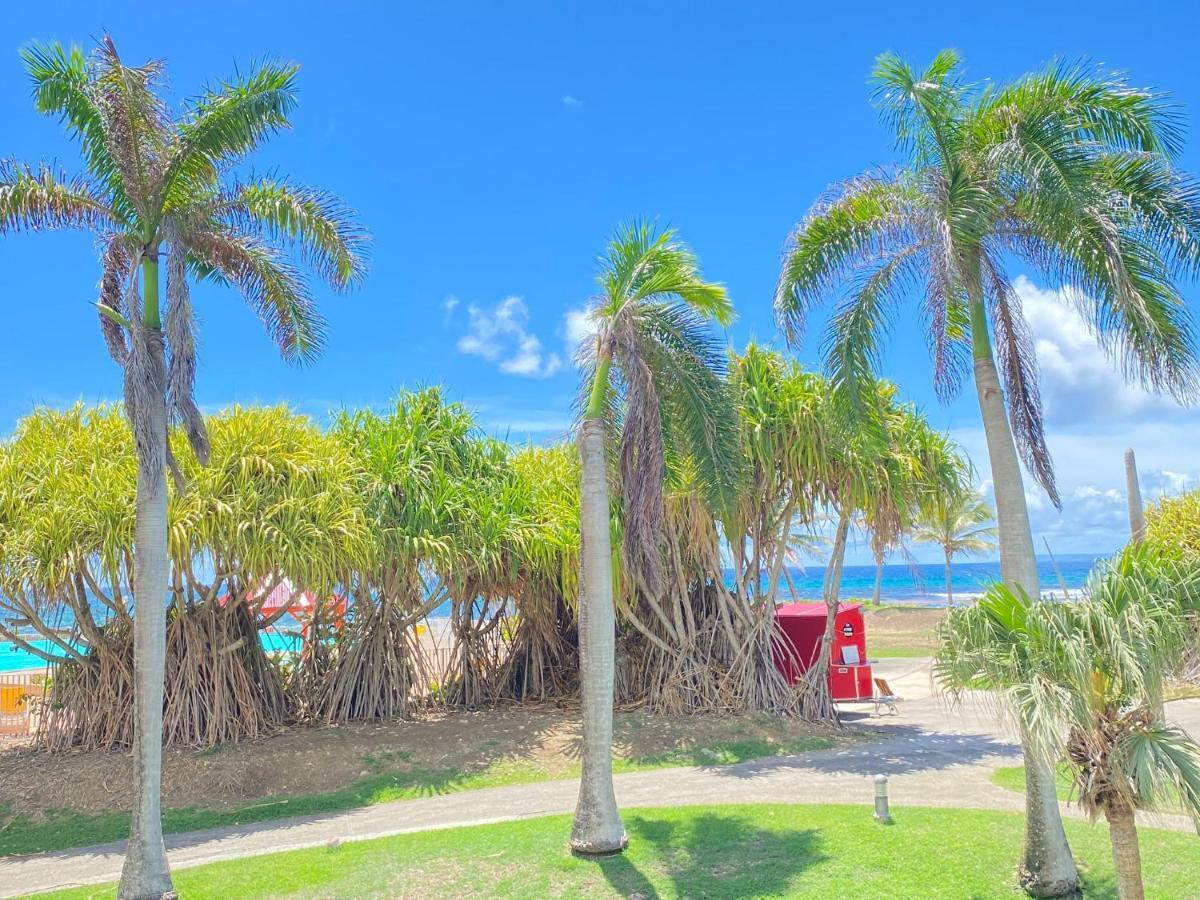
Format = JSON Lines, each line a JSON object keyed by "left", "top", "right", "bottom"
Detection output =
{"left": 775, "top": 604, "right": 874, "bottom": 700}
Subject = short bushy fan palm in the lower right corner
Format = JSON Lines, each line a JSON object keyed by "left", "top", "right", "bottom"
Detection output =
{"left": 935, "top": 546, "right": 1200, "bottom": 900}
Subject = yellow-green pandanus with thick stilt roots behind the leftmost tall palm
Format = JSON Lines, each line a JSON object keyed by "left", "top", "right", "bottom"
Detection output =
{"left": 0, "top": 406, "right": 366, "bottom": 751}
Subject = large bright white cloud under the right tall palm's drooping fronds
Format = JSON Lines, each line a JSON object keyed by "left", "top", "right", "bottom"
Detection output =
{"left": 1013, "top": 275, "right": 1180, "bottom": 426}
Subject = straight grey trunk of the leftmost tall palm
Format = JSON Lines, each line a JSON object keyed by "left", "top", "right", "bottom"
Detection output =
{"left": 118, "top": 259, "right": 175, "bottom": 900}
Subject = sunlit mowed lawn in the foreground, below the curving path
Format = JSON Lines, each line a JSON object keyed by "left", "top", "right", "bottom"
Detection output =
{"left": 39, "top": 805, "right": 1200, "bottom": 900}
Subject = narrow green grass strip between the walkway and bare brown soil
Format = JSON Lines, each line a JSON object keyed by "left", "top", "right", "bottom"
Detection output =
{"left": 0, "top": 737, "right": 836, "bottom": 857}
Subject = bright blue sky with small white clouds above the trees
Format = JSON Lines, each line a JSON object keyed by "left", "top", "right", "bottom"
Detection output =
{"left": 0, "top": 0, "right": 1200, "bottom": 564}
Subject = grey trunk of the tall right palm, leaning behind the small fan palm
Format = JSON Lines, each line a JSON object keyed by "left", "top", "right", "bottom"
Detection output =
{"left": 971, "top": 295, "right": 1079, "bottom": 896}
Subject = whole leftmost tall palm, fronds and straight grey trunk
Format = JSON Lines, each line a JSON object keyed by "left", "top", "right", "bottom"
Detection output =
{"left": 0, "top": 36, "right": 365, "bottom": 898}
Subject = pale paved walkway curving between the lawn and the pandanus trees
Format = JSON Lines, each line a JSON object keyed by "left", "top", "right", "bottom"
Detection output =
{"left": 0, "top": 659, "right": 1200, "bottom": 896}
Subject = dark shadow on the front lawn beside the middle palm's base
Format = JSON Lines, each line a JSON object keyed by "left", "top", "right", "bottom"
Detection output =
{"left": 596, "top": 811, "right": 827, "bottom": 900}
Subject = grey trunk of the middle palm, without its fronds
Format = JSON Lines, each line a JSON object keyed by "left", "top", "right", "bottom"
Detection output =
{"left": 571, "top": 416, "right": 629, "bottom": 854}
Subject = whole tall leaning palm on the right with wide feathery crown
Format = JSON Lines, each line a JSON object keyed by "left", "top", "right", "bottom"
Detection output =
{"left": 775, "top": 52, "right": 1200, "bottom": 894}
